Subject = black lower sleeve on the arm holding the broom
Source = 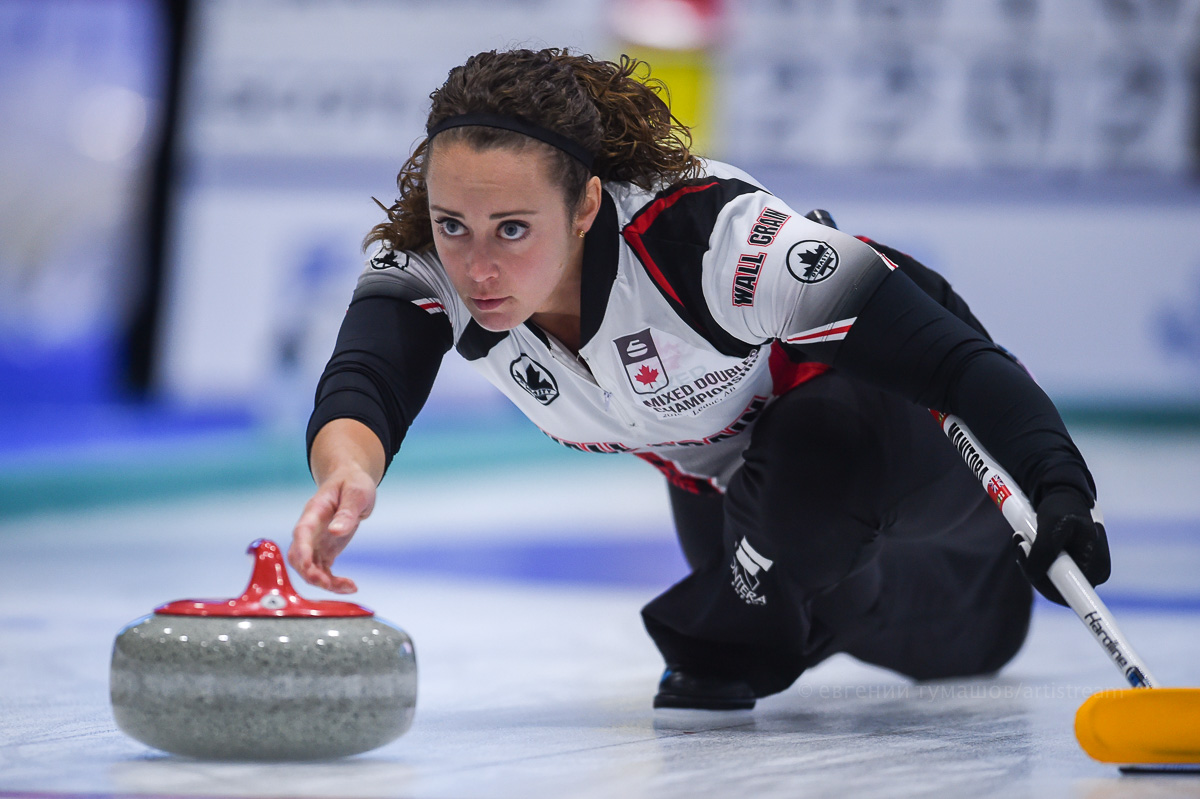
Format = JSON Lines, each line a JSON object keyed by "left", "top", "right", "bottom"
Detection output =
{"left": 834, "top": 262, "right": 1096, "bottom": 507}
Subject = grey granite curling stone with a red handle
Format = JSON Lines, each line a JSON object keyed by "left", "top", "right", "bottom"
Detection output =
{"left": 110, "top": 539, "right": 416, "bottom": 761}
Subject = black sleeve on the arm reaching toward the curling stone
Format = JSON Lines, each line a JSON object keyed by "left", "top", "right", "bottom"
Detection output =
{"left": 307, "top": 296, "right": 454, "bottom": 468}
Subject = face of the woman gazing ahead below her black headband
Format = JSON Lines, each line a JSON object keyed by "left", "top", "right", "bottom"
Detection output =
{"left": 426, "top": 142, "right": 599, "bottom": 331}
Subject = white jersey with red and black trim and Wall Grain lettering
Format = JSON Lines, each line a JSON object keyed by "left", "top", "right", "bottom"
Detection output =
{"left": 355, "top": 162, "right": 894, "bottom": 491}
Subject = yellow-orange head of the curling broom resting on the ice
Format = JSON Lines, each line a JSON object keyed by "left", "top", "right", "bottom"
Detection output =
{"left": 1075, "top": 687, "right": 1200, "bottom": 764}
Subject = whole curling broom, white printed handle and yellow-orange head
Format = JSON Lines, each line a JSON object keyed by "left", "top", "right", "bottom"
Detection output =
{"left": 931, "top": 410, "right": 1200, "bottom": 771}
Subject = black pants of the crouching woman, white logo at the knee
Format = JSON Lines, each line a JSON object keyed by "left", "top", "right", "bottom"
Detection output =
{"left": 642, "top": 373, "right": 1032, "bottom": 696}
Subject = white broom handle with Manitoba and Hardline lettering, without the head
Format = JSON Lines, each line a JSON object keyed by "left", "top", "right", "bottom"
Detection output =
{"left": 930, "top": 410, "right": 1158, "bottom": 687}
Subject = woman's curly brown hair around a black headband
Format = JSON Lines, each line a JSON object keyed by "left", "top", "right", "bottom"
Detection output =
{"left": 362, "top": 48, "right": 701, "bottom": 252}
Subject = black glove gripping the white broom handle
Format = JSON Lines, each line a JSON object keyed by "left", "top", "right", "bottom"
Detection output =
{"left": 1014, "top": 488, "right": 1112, "bottom": 605}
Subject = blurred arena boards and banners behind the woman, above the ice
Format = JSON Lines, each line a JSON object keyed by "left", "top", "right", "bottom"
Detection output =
{"left": 0, "top": 0, "right": 1200, "bottom": 518}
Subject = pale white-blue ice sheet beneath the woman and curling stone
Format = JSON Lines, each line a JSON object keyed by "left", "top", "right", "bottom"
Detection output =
{"left": 0, "top": 435, "right": 1200, "bottom": 799}
